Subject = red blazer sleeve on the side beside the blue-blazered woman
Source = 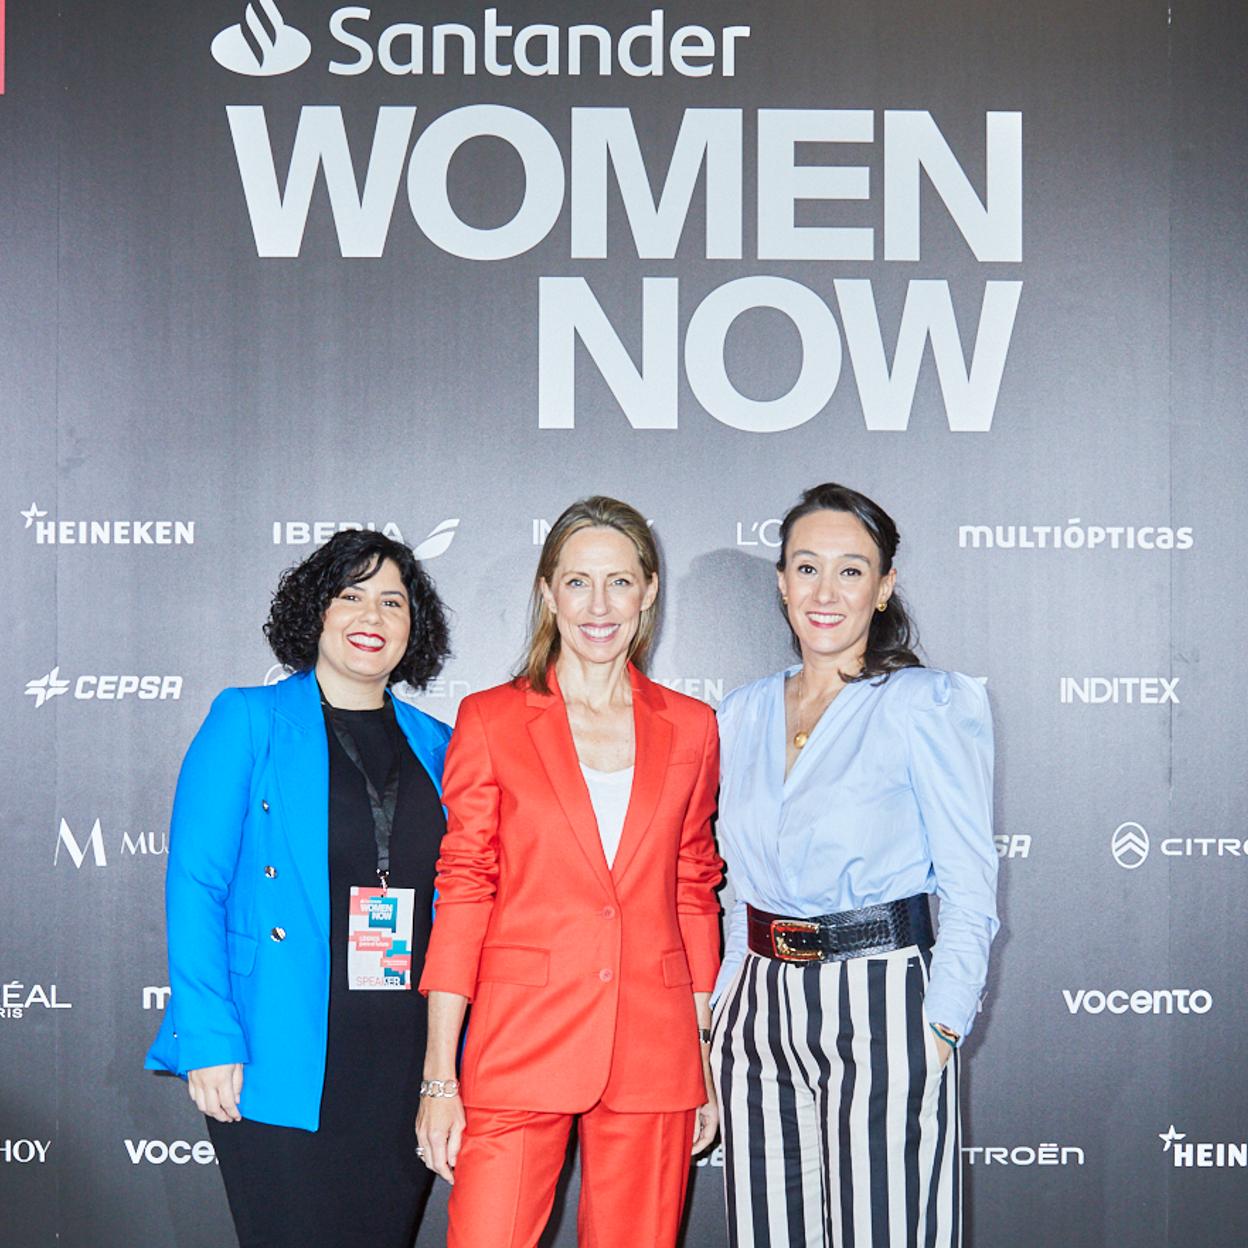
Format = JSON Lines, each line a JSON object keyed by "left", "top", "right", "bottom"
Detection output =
{"left": 419, "top": 698, "right": 499, "bottom": 1000}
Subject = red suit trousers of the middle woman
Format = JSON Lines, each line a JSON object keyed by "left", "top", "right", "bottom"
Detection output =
{"left": 447, "top": 1102, "right": 695, "bottom": 1248}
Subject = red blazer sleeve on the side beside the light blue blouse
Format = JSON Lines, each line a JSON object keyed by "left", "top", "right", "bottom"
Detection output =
{"left": 676, "top": 708, "right": 724, "bottom": 992}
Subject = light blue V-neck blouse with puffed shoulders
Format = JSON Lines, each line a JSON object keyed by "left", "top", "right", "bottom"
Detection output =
{"left": 715, "top": 668, "right": 1000, "bottom": 1036}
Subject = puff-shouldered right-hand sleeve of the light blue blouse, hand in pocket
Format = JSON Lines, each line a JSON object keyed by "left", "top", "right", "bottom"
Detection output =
{"left": 910, "top": 671, "right": 1000, "bottom": 1036}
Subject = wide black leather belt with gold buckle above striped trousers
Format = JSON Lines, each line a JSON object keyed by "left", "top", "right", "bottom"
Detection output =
{"left": 746, "top": 892, "right": 936, "bottom": 962}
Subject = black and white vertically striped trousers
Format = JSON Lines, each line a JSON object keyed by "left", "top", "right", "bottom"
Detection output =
{"left": 713, "top": 946, "right": 962, "bottom": 1248}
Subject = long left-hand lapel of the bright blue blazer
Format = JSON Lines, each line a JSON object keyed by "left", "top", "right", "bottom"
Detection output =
{"left": 272, "top": 671, "right": 329, "bottom": 940}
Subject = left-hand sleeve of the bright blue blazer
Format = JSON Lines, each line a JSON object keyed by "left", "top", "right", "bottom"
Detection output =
{"left": 165, "top": 689, "right": 255, "bottom": 1075}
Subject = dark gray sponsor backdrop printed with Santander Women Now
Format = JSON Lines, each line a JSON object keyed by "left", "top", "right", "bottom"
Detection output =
{"left": 0, "top": 0, "right": 1248, "bottom": 1248}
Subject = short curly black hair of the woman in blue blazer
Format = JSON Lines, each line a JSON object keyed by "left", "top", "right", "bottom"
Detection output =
{"left": 265, "top": 529, "right": 451, "bottom": 689}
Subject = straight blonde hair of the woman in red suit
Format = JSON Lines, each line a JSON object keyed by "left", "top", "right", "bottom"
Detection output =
{"left": 517, "top": 494, "right": 659, "bottom": 694}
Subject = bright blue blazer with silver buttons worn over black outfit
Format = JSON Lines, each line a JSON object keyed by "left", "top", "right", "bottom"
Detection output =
{"left": 145, "top": 671, "right": 451, "bottom": 1131}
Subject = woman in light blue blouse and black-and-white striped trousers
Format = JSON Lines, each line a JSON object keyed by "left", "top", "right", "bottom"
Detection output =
{"left": 713, "top": 484, "right": 998, "bottom": 1248}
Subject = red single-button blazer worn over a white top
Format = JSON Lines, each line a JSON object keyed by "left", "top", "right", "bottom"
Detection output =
{"left": 421, "top": 666, "right": 723, "bottom": 1113}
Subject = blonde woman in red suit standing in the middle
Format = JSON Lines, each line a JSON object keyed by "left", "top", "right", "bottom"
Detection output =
{"left": 417, "top": 497, "right": 721, "bottom": 1248}
